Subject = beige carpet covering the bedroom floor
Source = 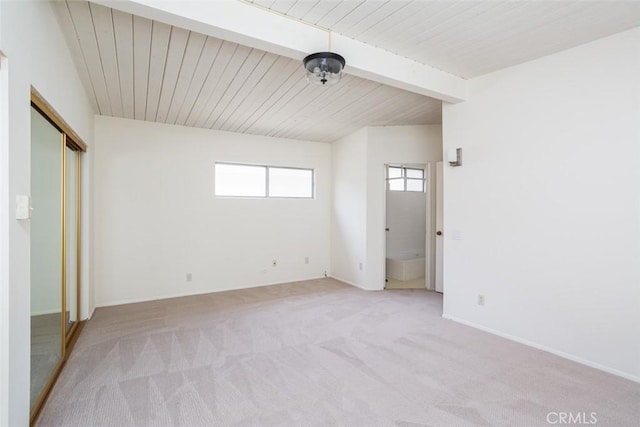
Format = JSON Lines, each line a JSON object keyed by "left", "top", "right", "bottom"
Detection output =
{"left": 38, "top": 279, "right": 640, "bottom": 427}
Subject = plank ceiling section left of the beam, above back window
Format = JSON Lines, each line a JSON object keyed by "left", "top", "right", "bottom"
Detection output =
{"left": 55, "top": 1, "right": 441, "bottom": 142}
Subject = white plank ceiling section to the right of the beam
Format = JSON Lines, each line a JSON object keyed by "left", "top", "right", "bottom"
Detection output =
{"left": 245, "top": 0, "right": 640, "bottom": 78}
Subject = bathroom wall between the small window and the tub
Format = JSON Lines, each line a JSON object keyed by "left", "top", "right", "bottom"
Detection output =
{"left": 386, "top": 191, "right": 427, "bottom": 257}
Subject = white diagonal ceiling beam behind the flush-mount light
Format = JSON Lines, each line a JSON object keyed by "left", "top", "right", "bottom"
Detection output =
{"left": 92, "top": 0, "right": 468, "bottom": 103}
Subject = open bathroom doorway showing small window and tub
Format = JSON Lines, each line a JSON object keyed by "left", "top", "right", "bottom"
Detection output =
{"left": 385, "top": 164, "right": 432, "bottom": 289}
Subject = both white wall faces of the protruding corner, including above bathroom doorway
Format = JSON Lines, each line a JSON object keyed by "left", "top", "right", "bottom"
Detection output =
{"left": 331, "top": 125, "right": 442, "bottom": 290}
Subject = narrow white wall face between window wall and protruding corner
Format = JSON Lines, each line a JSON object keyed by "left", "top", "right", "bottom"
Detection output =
{"left": 331, "top": 128, "right": 368, "bottom": 287}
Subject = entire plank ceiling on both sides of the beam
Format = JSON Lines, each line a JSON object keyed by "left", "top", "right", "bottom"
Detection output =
{"left": 54, "top": 0, "right": 640, "bottom": 142}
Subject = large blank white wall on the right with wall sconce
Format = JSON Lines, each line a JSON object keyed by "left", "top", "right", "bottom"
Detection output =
{"left": 443, "top": 29, "right": 640, "bottom": 381}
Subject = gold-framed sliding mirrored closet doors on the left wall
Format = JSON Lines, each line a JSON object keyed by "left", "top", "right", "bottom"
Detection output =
{"left": 30, "top": 91, "right": 86, "bottom": 422}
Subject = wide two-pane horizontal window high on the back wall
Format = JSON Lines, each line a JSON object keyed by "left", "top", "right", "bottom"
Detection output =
{"left": 215, "top": 163, "right": 314, "bottom": 199}
